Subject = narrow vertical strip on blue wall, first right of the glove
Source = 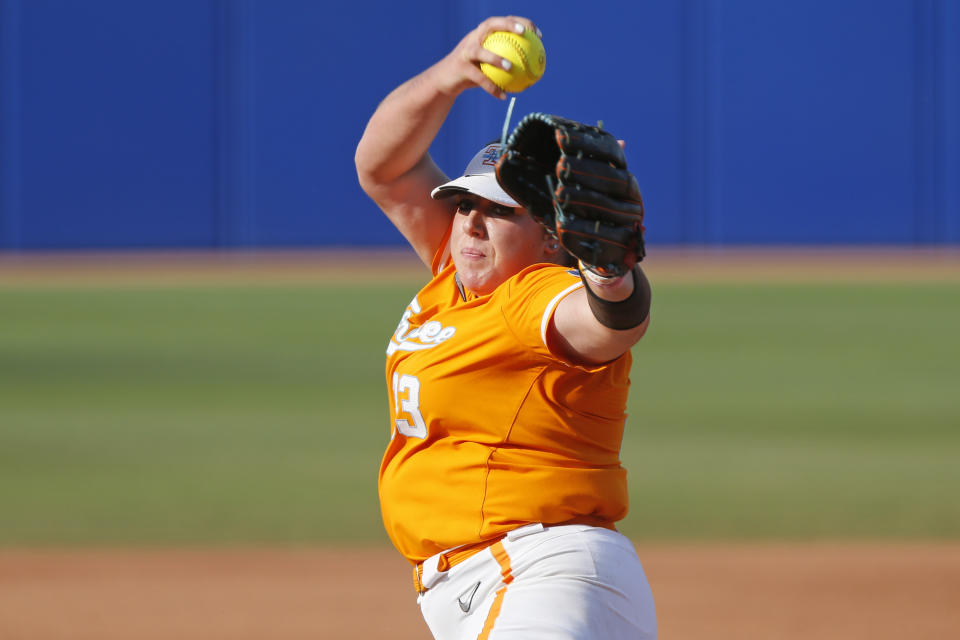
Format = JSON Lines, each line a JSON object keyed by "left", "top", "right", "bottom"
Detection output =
{"left": 704, "top": 0, "right": 723, "bottom": 245}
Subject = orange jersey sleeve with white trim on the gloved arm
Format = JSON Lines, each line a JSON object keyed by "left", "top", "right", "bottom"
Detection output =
{"left": 500, "top": 264, "right": 583, "bottom": 364}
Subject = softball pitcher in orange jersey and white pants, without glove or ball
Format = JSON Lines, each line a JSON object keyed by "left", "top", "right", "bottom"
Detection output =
{"left": 356, "top": 16, "right": 656, "bottom": 640}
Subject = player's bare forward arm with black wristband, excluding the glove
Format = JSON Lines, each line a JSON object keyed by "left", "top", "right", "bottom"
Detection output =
{"left": 547, "top": 265, "right": 651, "bottom": 365}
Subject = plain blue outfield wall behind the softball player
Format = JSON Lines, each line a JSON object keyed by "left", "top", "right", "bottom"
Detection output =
{"left": 0, "top": 0, "right": 960, "bottom": 250}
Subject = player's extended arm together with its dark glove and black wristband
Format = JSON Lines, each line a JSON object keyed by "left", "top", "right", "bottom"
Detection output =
{"left": 497, "top": 113, "right": 650, "bottom": 365}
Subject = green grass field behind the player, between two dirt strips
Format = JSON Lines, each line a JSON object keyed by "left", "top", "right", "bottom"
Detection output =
{"left": 0, "top": 283, "right": 960, "bottom": 546}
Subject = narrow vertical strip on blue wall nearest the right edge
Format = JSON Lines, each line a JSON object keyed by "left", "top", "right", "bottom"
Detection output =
{"left": 913, "top": 0, "right": 937, "bottom": 244}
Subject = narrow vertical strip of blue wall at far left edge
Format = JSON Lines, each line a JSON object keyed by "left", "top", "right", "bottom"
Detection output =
{"left": 0, "top": 0, "right": 23, "bottom": 249}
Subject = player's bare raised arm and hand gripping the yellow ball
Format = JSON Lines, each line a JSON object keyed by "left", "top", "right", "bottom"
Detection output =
{"left": 354, "top": 16, "right": 536, "bottom": 267}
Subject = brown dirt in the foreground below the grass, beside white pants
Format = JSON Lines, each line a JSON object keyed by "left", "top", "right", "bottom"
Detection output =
{"left": 0, "top": 543, "right": 960, "bottom": 640}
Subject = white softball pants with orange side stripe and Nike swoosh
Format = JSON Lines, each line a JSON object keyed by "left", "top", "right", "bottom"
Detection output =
{"left": 418, "top": 524, "right": 657, "bottom": 640}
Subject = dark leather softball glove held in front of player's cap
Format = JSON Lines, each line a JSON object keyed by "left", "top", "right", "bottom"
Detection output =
{"left": 497, "top": 113, "right": 644, "bottom": 276}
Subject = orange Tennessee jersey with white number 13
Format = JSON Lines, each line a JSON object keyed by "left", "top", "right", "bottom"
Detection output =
{"left": 379, "top": 242, "right": 631, "bottom": 562}
